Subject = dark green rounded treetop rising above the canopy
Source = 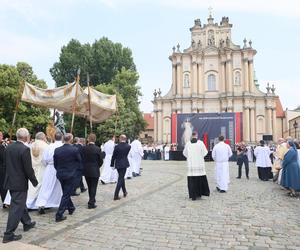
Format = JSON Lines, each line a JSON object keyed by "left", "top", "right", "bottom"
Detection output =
{"left": 50, "top": 37, "right": 135, "bottom": 86}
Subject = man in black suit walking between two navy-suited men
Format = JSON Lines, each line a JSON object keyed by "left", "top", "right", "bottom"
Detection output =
{"left": 82, "top": 133, "right": 103, "bottom": 209}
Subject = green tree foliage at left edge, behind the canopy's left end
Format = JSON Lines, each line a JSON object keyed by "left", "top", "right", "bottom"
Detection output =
{"left": 0, "top": 62, "right": 50, "bottom": 138}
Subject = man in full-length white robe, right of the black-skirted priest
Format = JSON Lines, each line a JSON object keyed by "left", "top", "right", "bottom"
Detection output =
{"left": 212, "top": 135, "right": 232, "bottom": 193}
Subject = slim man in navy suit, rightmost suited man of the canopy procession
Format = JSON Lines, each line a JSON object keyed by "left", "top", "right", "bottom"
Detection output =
{"left": 110, "top": 135, "right": 130, "bottom": 200}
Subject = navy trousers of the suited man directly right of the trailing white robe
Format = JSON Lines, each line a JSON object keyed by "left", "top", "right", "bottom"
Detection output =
{"left": 56, "top": 178, "right": 76, "bottom": 218}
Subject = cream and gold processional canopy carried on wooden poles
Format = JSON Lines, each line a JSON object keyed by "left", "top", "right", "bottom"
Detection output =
{"left": 21, "top": 82, "right": 117, "bottom": 122}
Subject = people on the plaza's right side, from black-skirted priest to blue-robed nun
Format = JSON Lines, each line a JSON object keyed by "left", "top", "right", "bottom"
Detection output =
{"left": 183, "top": 132, "right": 300, "bottom": 200}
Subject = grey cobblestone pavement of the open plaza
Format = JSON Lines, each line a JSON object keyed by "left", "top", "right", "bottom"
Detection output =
{"left": 0, "top": 161, "right": 300, "bottom": 250}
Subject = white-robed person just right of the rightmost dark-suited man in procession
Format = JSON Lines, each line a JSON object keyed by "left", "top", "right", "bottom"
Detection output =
{"left": 130, "top": 139, "right": 144, "bottom": 177}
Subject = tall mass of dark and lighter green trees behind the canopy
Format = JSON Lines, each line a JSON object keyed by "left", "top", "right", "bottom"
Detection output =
{"left": 50, "top": 37, "right": 146, "bottom": 142}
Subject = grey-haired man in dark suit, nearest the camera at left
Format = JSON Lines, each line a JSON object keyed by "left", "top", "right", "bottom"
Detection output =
{"left": 3, "top": 128, "right": 38, "bottom": 243}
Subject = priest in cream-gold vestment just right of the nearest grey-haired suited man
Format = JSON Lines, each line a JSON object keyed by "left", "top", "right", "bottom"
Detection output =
{"left": 26, "top": 132, "right": 48, "bottom": 209}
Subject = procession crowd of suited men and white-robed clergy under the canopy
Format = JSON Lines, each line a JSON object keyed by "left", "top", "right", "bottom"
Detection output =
{"left": 0, "top": 128, "right": 143, "bottom": 243}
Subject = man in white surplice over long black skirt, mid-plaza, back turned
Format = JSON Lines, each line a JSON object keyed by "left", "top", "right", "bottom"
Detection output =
{"left": 183, "top": 132, "right": 210, "bottom": 201}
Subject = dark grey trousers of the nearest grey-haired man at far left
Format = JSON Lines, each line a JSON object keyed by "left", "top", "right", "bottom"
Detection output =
{"left": 4, "top": 191, "right": 31, "bottom": 238}
